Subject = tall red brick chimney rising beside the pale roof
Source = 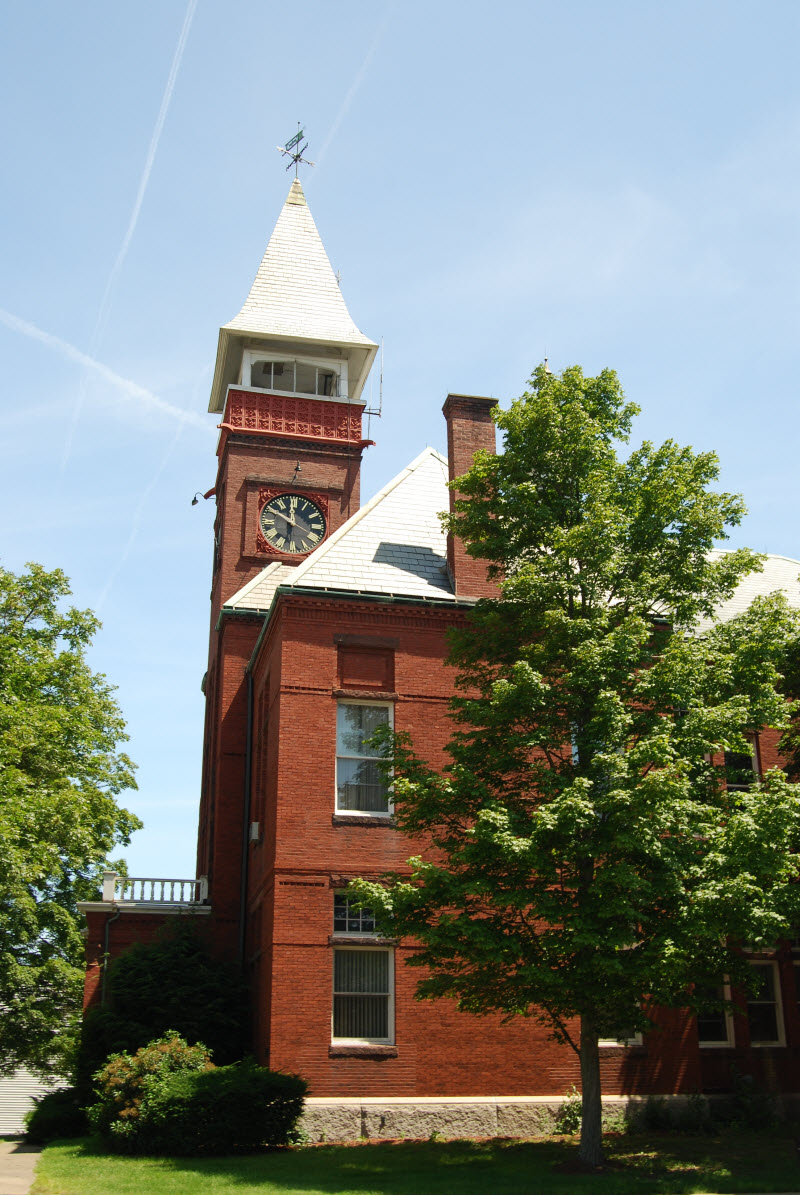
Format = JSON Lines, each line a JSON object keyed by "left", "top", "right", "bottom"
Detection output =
{"left": 441, "top": 394, "right": 497, "bottom": 598}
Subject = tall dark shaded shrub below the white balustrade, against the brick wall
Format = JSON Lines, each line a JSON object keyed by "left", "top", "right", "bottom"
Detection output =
{"left": 75, "top": 923, "right": 249, "bottom": 1102}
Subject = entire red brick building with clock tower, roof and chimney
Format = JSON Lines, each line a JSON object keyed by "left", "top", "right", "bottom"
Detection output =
{"left": 79, "top": 180, "right": 800, "bottom": 1139}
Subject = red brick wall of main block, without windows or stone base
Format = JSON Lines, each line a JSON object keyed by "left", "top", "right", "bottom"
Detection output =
{"left": 234, "top": 595, "right": 771, "bottom": 1097}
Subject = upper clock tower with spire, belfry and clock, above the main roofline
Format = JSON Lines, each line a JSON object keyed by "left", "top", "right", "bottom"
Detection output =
{"left": 208, "top": 178, "right": 377, "bottom": 626}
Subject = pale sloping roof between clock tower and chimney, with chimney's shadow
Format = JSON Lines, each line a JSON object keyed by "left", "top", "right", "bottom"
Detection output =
{"left": 222, "top": 448, "right": 456, "bottom": 611}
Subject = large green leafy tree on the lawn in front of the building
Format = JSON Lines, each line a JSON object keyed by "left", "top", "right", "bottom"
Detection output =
{"left": 354, "top": 368, "right": 800, "bottom": 1165}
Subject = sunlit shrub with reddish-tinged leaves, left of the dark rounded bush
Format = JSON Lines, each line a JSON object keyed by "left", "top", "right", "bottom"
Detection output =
{"left": 88, "top": 1032, "right": 213, "bottom": 1136}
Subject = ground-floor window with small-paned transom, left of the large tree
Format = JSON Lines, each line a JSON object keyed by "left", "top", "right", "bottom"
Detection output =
{"left": 332, "top": 895, "right": 395, "bottom": 1044}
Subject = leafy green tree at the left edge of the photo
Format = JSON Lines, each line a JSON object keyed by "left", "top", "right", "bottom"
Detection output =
{"left": 0, "top": 564, "right": 141, "bottom": 1074}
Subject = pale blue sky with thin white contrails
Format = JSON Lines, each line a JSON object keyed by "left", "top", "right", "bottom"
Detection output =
{"left": 0, "top": 0, "right": 800, "bottom": 876}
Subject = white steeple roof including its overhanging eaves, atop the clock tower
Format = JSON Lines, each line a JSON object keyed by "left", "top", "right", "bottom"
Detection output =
{"left": 208, "top": 178, "right": 378, "bottom": 411}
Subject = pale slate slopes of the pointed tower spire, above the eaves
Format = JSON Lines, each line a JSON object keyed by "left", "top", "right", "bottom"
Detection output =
{"left": 224, "top": 178, "right": 374, "bottom": 347}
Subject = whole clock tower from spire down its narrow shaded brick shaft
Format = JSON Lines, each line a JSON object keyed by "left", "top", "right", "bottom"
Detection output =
{"left": 197, "top": 178, "right": 378, "bottom": 941}
